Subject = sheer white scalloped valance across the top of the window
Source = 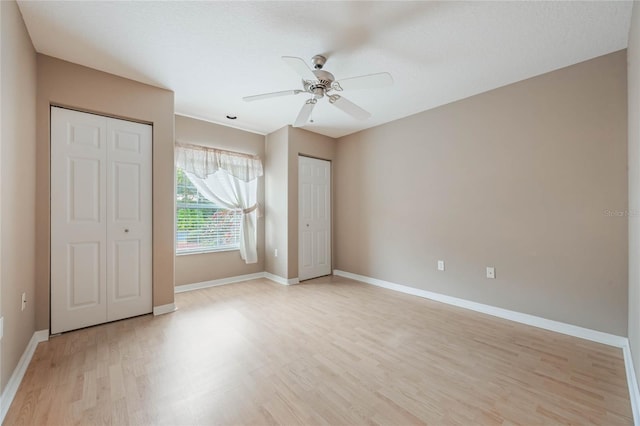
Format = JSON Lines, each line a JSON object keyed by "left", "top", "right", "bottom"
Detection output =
{"left": 176, "top": 142, "right": 263, "bottom": 182}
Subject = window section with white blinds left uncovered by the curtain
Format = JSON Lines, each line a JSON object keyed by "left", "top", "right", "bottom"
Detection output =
{"left": 176, "top": 168, "right": 242, "bottom": 254}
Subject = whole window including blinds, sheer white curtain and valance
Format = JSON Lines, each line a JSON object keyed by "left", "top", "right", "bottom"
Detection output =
{"left": 175, "top": 142, "right": 263, "bottom": 264}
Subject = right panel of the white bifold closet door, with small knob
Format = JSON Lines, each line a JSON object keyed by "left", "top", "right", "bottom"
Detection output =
{"left": 107, "top": 119, "right": 153, "bottom": 321}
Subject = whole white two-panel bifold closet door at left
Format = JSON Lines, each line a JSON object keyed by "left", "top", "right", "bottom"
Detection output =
{"left": 51, "top": 107, "right": 153, "bottom": 334}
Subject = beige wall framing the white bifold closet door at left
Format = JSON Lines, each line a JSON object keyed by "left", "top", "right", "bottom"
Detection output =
{"left": 36, "top": 54, "right": 175, "bottom": 329}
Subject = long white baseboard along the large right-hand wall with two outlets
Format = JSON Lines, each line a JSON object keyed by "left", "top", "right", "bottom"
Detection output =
{"left": 333, "top": 269, "right": 627, "bottom": 348}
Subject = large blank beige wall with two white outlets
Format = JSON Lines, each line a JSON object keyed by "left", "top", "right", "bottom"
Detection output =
{"left": 334, "top": 51, "right": 637, "bottom": 336}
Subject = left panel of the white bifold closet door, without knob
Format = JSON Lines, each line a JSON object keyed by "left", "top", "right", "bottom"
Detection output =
{"left": 51, "top": 108, "right": 107, "bottom": 334}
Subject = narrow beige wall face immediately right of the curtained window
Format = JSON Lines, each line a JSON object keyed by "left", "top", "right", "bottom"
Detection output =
{"left": 264, "top": 127, "right": 289, "bottom": 278}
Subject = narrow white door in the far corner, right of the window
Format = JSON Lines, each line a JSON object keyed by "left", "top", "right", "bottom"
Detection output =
{"left": 298, "top": 156, "right": 331, "bottom": 280}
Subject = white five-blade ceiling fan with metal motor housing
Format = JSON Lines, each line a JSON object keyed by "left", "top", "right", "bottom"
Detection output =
{"left": 242, "top": 55, "right": 393, "bottom": 127}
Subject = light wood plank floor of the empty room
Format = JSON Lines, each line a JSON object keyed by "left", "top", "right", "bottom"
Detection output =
{"left": 5, "top": 277, "right": 632, "bottom": 425}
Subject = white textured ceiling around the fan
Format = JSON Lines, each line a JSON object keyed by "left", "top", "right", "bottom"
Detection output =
{"left": 19, "top": 1, "right": 632, "bottom": 137}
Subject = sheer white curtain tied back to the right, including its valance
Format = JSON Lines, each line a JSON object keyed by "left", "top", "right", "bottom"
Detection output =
{"left": 176, "top": 144, "right": 263, "bottom": 263}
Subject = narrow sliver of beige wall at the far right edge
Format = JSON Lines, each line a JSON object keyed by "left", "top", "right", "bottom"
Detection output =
{"left": 627, "top": 4, "right": 640, "bottom": 382}
